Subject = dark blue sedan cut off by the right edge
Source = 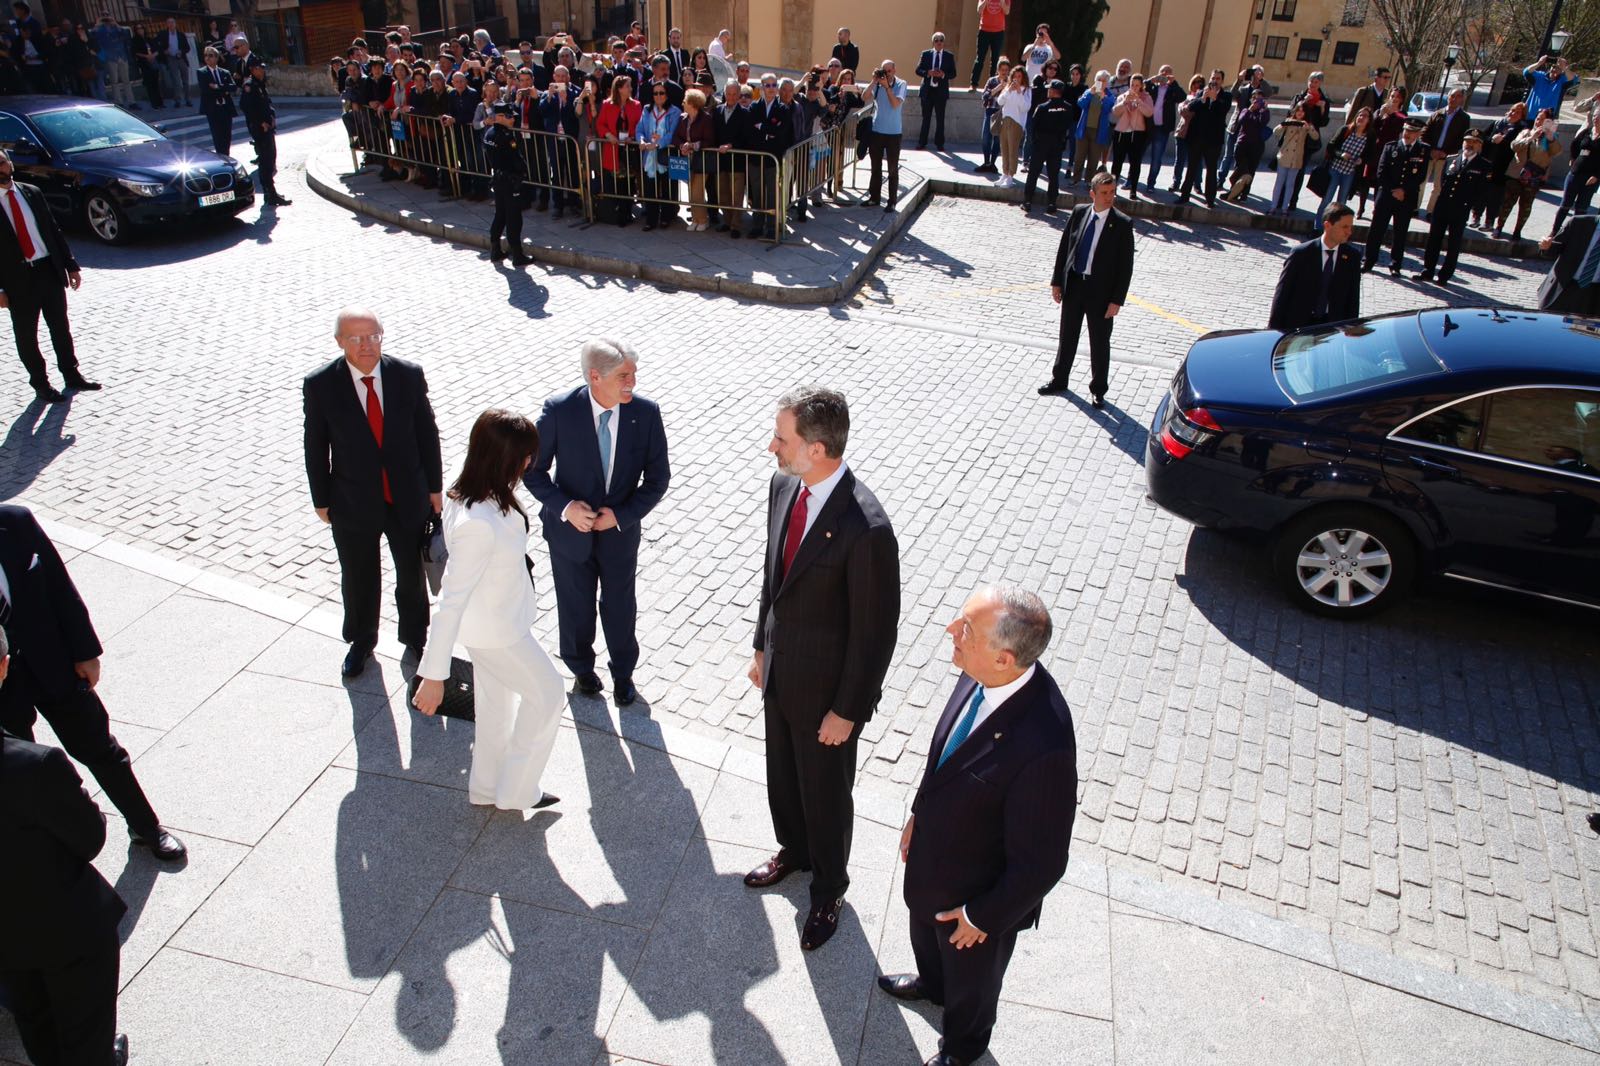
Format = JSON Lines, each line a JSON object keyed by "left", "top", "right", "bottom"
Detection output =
{"left": 1144, "top": 307, "right": 1600, "bottom": 618}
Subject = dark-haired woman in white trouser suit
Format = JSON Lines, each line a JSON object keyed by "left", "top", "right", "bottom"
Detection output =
{"left": 413, "top": 410, "right": 565, "bottom": 810}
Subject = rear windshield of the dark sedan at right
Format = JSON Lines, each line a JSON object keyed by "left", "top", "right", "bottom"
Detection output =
{"left": 1272, "top": 315, "right": 1445, "bottom": 403}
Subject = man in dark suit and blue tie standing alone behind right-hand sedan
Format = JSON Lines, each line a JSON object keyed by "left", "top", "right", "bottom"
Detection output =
{"left": 1038, "top": 170, "right": 1133, "bottom": 407}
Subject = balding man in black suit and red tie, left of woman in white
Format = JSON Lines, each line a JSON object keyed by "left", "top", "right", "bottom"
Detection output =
{"left": 304, "top": 307, "right": 445, "bottom": 677}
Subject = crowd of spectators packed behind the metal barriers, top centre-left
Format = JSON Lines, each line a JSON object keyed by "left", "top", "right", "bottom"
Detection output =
{"left": 340, "top": 27, "right": 904, "bottom": 237}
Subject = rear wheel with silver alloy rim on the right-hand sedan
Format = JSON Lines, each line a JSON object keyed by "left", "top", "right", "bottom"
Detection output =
{"left": 1277, "top": 507, "right": 1413, "bottom": 618}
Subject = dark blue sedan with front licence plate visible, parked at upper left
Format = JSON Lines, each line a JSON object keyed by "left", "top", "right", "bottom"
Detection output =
{"left": 0, "top": 96, "right": 256, "bottom": 245}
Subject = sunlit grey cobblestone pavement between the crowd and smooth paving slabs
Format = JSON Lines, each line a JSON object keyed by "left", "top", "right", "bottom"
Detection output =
{"left": 9, "top": 123, "right": 1600, "bottom": 1010}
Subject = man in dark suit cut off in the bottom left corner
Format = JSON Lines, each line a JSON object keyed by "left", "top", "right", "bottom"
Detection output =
{"left": 0, "top": 629, "right": 128, "bottom": 1066}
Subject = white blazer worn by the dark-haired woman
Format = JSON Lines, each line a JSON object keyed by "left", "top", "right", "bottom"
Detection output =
{"left": 416, "top": 499, "right": 538, "bottom": 680}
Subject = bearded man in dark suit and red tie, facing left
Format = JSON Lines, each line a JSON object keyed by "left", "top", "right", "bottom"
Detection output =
{"left": 744, "top": 387, "right": 899, "bottom": 951}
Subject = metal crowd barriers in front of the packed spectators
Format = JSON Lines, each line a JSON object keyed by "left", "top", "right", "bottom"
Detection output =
{"left": 344, "top": 92, "right": 874, "bottom": 242}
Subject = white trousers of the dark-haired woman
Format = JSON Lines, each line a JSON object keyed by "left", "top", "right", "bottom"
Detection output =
{"left": 467, "top": 632, "right": 566, "bottom": 810}
